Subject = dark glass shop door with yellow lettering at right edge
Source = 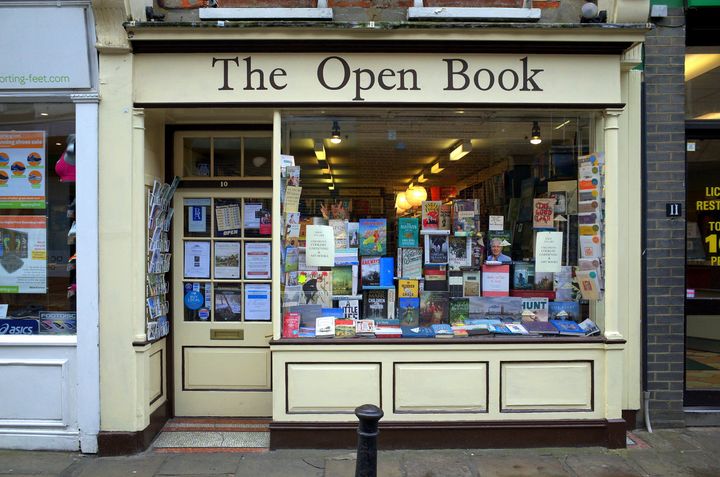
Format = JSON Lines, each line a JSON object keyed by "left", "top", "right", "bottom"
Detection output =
{"left": 685, "top": 133, "right": 720, "bottom": 407}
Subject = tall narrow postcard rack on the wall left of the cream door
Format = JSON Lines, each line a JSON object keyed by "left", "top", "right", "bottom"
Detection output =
{"left": 145, "top": 177, "right": 180, "bottom": 341}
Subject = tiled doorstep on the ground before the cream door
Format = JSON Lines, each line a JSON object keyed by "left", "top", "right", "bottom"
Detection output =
{"left": 152, "top": 418, "right": 270, "bottom": 453}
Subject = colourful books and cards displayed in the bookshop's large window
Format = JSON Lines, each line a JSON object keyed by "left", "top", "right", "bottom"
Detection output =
{"left": 281, "top": 154, "right": 603, "bottom": 339}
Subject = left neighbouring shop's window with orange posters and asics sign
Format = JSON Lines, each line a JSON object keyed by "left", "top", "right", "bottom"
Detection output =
{"left": 0, "top": 103, "right": 77, "bottom": 335}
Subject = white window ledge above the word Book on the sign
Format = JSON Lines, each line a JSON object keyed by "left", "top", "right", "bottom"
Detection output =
{"left": 408, "top": 7, "right": 541, "bottom": 22}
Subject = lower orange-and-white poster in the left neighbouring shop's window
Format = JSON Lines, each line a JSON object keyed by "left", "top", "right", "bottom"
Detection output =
{"left": 0, "top": 215, "right": 47, "bottom": 293}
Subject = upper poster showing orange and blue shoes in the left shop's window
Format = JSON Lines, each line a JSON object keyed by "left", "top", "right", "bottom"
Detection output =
{"left": 0, "top": 131, "right": 46, "bottom": 209}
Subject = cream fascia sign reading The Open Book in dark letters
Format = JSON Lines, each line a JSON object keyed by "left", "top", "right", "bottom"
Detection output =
{"left": 134, "top": 53, "right": 620, "bottom": 105}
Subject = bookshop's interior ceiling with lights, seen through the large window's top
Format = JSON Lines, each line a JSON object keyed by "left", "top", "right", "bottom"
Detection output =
{"left": 283, "top": 110, "right": 588, "bottom": 192}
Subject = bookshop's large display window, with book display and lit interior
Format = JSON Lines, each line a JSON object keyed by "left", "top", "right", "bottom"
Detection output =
{"left": 276, "top": 110, "right": 604, "bottom": 339}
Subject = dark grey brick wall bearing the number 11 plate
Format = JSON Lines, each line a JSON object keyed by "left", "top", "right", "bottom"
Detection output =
{"left": 645, "top": 8, "right": 685, "bottom": 427}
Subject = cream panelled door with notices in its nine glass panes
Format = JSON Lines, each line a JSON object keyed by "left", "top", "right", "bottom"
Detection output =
{"left": 173, "top": 188, "right": 272, "bottom": 417}
